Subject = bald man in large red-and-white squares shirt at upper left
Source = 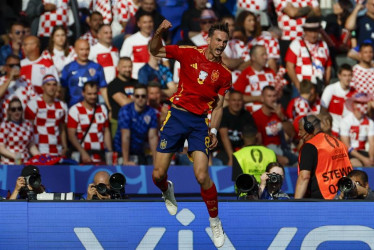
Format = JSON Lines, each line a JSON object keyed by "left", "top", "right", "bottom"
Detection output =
{"left": 21, "top": 36, "right": 59, "bottom": 95}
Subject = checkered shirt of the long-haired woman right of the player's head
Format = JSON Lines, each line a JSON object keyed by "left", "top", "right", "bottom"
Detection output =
{"left": 247, "top": 31, "right": 280, "bottom": 59}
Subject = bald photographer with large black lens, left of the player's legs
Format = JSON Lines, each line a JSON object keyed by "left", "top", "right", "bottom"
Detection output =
{"left": 86, "top": 171, "right": 126, "bottom": 200}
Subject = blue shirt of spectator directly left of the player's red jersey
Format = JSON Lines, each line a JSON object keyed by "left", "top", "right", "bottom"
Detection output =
{"left": 138, "top": 63, "right": 173, "bottom": 89}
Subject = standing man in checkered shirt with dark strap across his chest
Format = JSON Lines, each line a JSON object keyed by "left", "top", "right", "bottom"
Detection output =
{"left": 68, "top": 81, "right": 112, "bottom": 164}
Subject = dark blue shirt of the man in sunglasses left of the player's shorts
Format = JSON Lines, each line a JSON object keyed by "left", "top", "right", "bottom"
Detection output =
{"left": 114, "top": 103, "right": 157, "bottom": 154}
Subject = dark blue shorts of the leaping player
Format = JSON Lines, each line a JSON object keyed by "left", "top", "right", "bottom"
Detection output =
{"left": 157, "top": 107, "right": 210, "bottom": 156}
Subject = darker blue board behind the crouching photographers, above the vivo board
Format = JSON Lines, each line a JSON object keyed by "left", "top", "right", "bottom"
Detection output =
{"left": 0, "top": 165, "right": 374, "bottom": 194}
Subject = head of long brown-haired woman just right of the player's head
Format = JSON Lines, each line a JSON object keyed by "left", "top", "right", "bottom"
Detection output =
{"left": 236, "top": 10, "right": 261, "bottom": 44}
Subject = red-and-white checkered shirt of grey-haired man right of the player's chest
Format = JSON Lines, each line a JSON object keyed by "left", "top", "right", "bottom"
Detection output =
{"left": 234, "top": 66, "right": 276, "bottom": 113}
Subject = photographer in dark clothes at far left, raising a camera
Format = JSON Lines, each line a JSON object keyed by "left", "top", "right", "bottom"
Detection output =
{"left": 9, "top": 166, "right": 45, "bottom": 200}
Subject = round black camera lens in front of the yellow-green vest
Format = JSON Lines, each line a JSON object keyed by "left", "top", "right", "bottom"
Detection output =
{"left": 235, "top": 174, "right": 258, "bottom": 200}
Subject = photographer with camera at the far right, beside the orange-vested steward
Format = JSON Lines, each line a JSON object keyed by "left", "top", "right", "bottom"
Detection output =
{"left": 335, "top": 170, "right": 374, "bottom": 200}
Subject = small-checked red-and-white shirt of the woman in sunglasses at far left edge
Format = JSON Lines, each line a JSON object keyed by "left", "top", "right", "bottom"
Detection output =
{"left": 0, "top": 121, "right": 34, "bottom": 165}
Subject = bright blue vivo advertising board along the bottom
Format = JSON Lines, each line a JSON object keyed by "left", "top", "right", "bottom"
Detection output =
{"left": 0, "top": 201, "right": 374, "bottom": 250}
